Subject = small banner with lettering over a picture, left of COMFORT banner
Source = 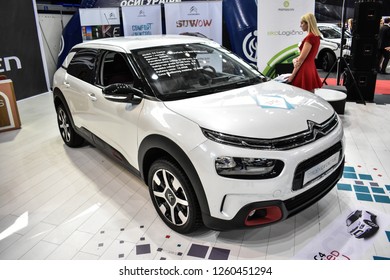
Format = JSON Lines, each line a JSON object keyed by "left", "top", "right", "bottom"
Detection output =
{"left": 79, "top": 8, "right": 121, "bottom": 41}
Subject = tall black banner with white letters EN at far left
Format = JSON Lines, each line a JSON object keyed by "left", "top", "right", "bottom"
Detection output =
{"left": 0, "top": 0, "right": 50, "bottom": 100}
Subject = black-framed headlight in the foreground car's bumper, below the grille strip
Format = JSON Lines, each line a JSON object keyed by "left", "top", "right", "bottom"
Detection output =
{"left": 215, "top": 156, "right": 284, "bottom": 179}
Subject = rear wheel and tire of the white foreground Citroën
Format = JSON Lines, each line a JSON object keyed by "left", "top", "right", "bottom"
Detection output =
{"left": 57, "top": 105, "right": 84, "bottom": 148}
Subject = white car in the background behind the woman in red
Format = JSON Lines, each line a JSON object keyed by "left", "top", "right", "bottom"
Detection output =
{"left": 316, "top": 23, "right": 352, "bottom": 71}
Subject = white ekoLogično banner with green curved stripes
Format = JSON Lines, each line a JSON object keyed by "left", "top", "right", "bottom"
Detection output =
{"left": 257, "top": 0, "right": 315, "bottom": 77}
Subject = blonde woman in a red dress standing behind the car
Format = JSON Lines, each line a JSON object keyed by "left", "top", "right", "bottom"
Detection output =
{"left": 288, "top": 13, "right": 322, "bottom": 92}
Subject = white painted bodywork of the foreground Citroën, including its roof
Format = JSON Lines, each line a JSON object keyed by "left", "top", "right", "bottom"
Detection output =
{"left": 53, "top": 35, "right": 345, "bottom": 232}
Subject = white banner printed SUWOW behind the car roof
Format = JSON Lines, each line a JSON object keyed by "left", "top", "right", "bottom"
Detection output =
{"left": 164, "top": 1, "right": 222, "bottom": 44}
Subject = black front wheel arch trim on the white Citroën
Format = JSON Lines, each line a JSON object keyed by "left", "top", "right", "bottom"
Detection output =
{"left": 138, "top": 134, "right": 210, "bottom": 219}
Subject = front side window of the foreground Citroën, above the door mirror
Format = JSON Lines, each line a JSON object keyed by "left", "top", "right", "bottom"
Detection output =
{"left": 100, "top": 52, "right": 134, "bottom": 86}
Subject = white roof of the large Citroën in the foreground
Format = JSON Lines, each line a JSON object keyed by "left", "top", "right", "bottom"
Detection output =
{"left": 73, "top": 35, "right": 212, "bottom": 51}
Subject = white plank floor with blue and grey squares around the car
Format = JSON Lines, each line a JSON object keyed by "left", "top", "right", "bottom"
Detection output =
{"left": 0, "top": 94, "right": 390, "bottom": 260}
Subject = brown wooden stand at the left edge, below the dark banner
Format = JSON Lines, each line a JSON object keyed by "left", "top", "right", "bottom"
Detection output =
{"left": 0, "top": 79, "right": 21, "bottom": 132}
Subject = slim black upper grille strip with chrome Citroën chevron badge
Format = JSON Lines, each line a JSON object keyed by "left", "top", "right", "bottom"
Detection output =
{"left": 202, "top": 114, "right": 339, "bottom": 150}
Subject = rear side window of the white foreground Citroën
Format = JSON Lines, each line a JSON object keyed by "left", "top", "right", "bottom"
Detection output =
{"left": 67, "top": 49, "right": 98, "bottom": 84}
